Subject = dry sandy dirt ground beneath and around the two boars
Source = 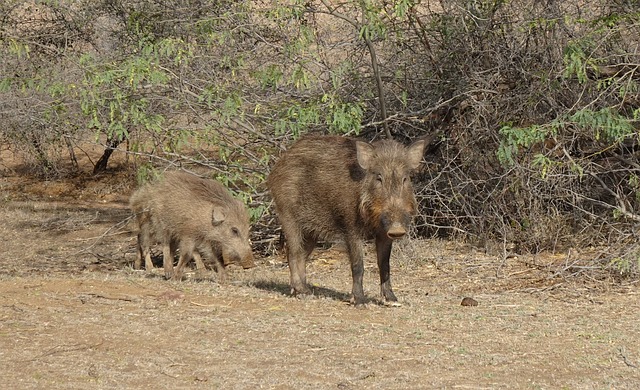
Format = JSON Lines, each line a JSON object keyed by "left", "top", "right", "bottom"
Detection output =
{"left": 0, "top": 164, "right": 640, "bottom": 389}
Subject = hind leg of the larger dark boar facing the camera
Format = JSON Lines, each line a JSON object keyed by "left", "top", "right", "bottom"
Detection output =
{"left": 282, "top": 224, "right": 317, "bottom": 295}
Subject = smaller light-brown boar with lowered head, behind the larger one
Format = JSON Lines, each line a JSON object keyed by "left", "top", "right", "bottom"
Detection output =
{"left": 130, "top": 172, "right": 254, "bottom": 281}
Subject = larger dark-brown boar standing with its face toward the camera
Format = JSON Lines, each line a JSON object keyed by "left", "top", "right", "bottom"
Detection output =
{"left": 267, "top": 136, "right": 426, "bottom": 305}
